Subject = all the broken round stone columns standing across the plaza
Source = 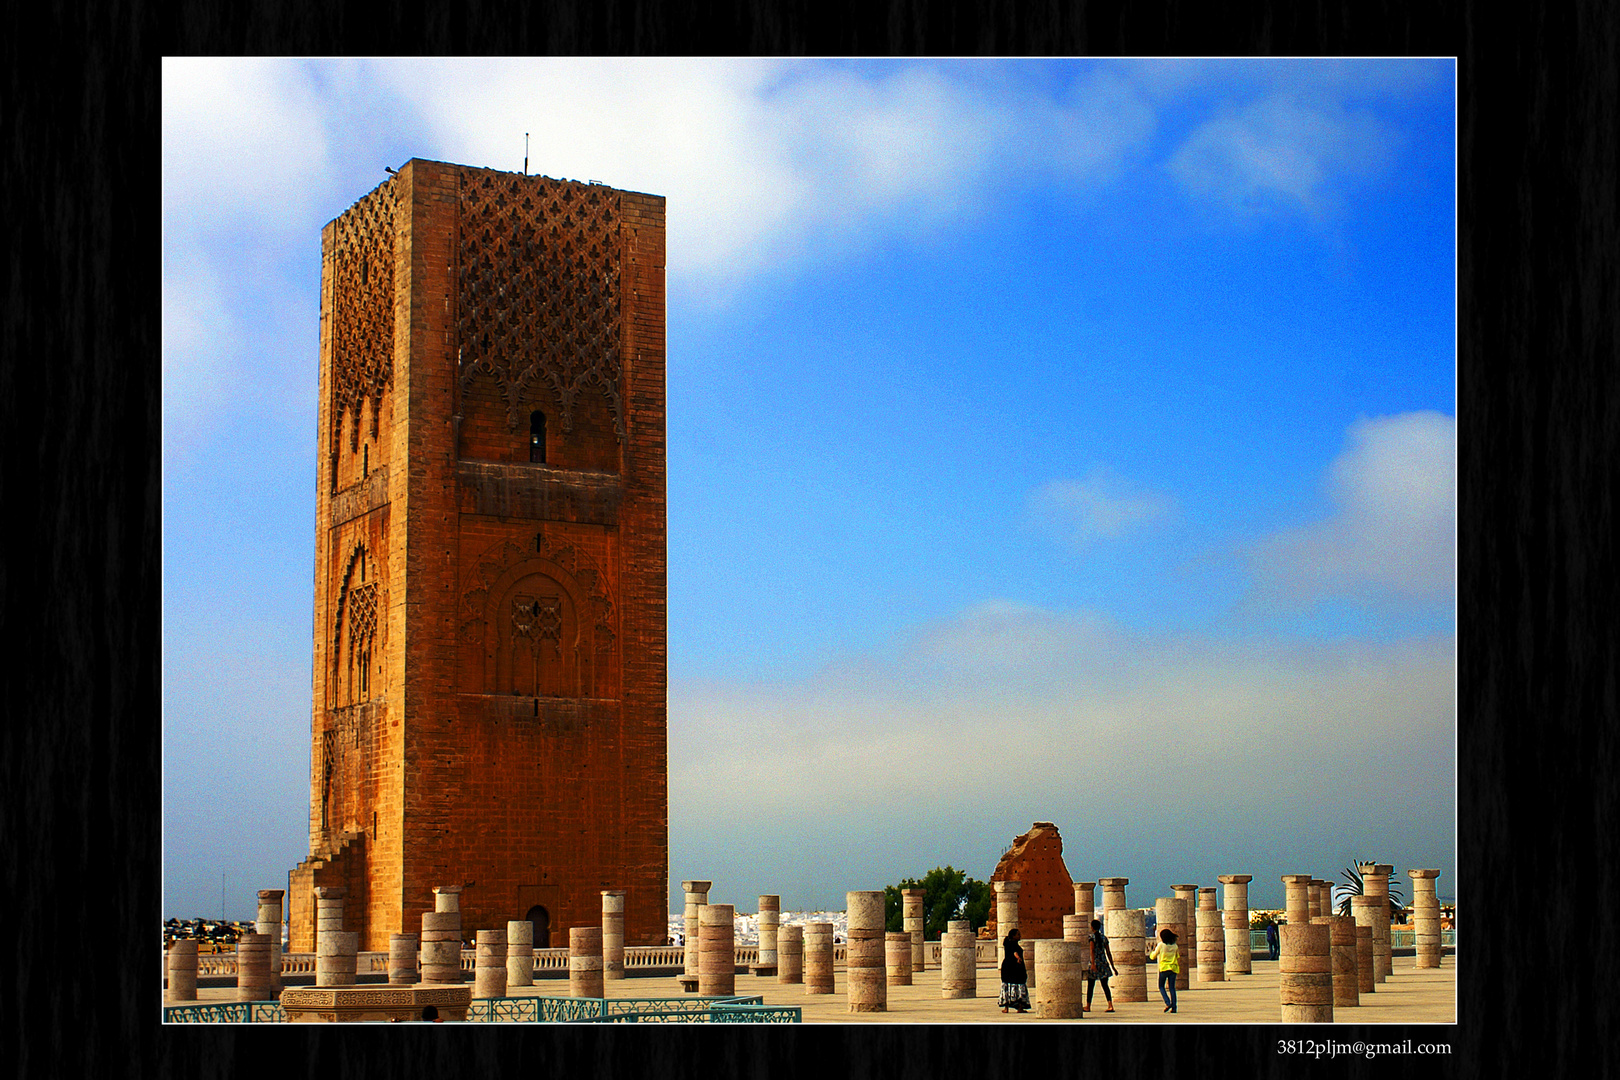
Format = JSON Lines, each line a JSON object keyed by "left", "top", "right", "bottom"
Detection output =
{"left": 165, "top": 863, "right": 1440, "bottom": 1022}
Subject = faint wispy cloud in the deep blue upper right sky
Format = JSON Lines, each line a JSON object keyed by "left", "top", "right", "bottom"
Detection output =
{"left": 1166, "top": 94, "right": 1396, "bottom": 219}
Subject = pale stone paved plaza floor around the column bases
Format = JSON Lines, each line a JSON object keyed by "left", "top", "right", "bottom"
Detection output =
{"left": 174, "top": 955, "right": 1456, "bottom": 1025}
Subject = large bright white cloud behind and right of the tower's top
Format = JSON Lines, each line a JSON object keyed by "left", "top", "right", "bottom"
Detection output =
{"left": 361, "top": 60, "right": 1153, "bottom": 302}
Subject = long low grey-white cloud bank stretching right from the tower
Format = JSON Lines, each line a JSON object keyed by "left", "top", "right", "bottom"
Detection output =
{"left": 669, "top": 602, "right": 1455, "bottom": 821}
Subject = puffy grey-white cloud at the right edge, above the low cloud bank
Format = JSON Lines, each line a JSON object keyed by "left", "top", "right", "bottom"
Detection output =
{"left": 1251, "top": 411, "right": 1456, "bottom": 604}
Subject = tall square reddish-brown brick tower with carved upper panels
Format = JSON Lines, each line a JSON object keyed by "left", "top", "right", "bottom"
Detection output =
{"left": 288, "top": 160, "right": 669, "bottom": 950}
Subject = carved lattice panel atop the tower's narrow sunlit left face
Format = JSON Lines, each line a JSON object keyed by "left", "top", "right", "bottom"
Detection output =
{"left": 330, "top": 180, "right": 395, "bottom": 453}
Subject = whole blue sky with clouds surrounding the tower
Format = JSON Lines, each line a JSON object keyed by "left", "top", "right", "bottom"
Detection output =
{"left": 162, "top": 60, "right": 1456, "bottom": 918}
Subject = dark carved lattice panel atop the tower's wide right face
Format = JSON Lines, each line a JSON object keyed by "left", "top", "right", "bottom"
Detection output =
{"left": 455, "top": 170, "right": 624, "bottom": 440}
